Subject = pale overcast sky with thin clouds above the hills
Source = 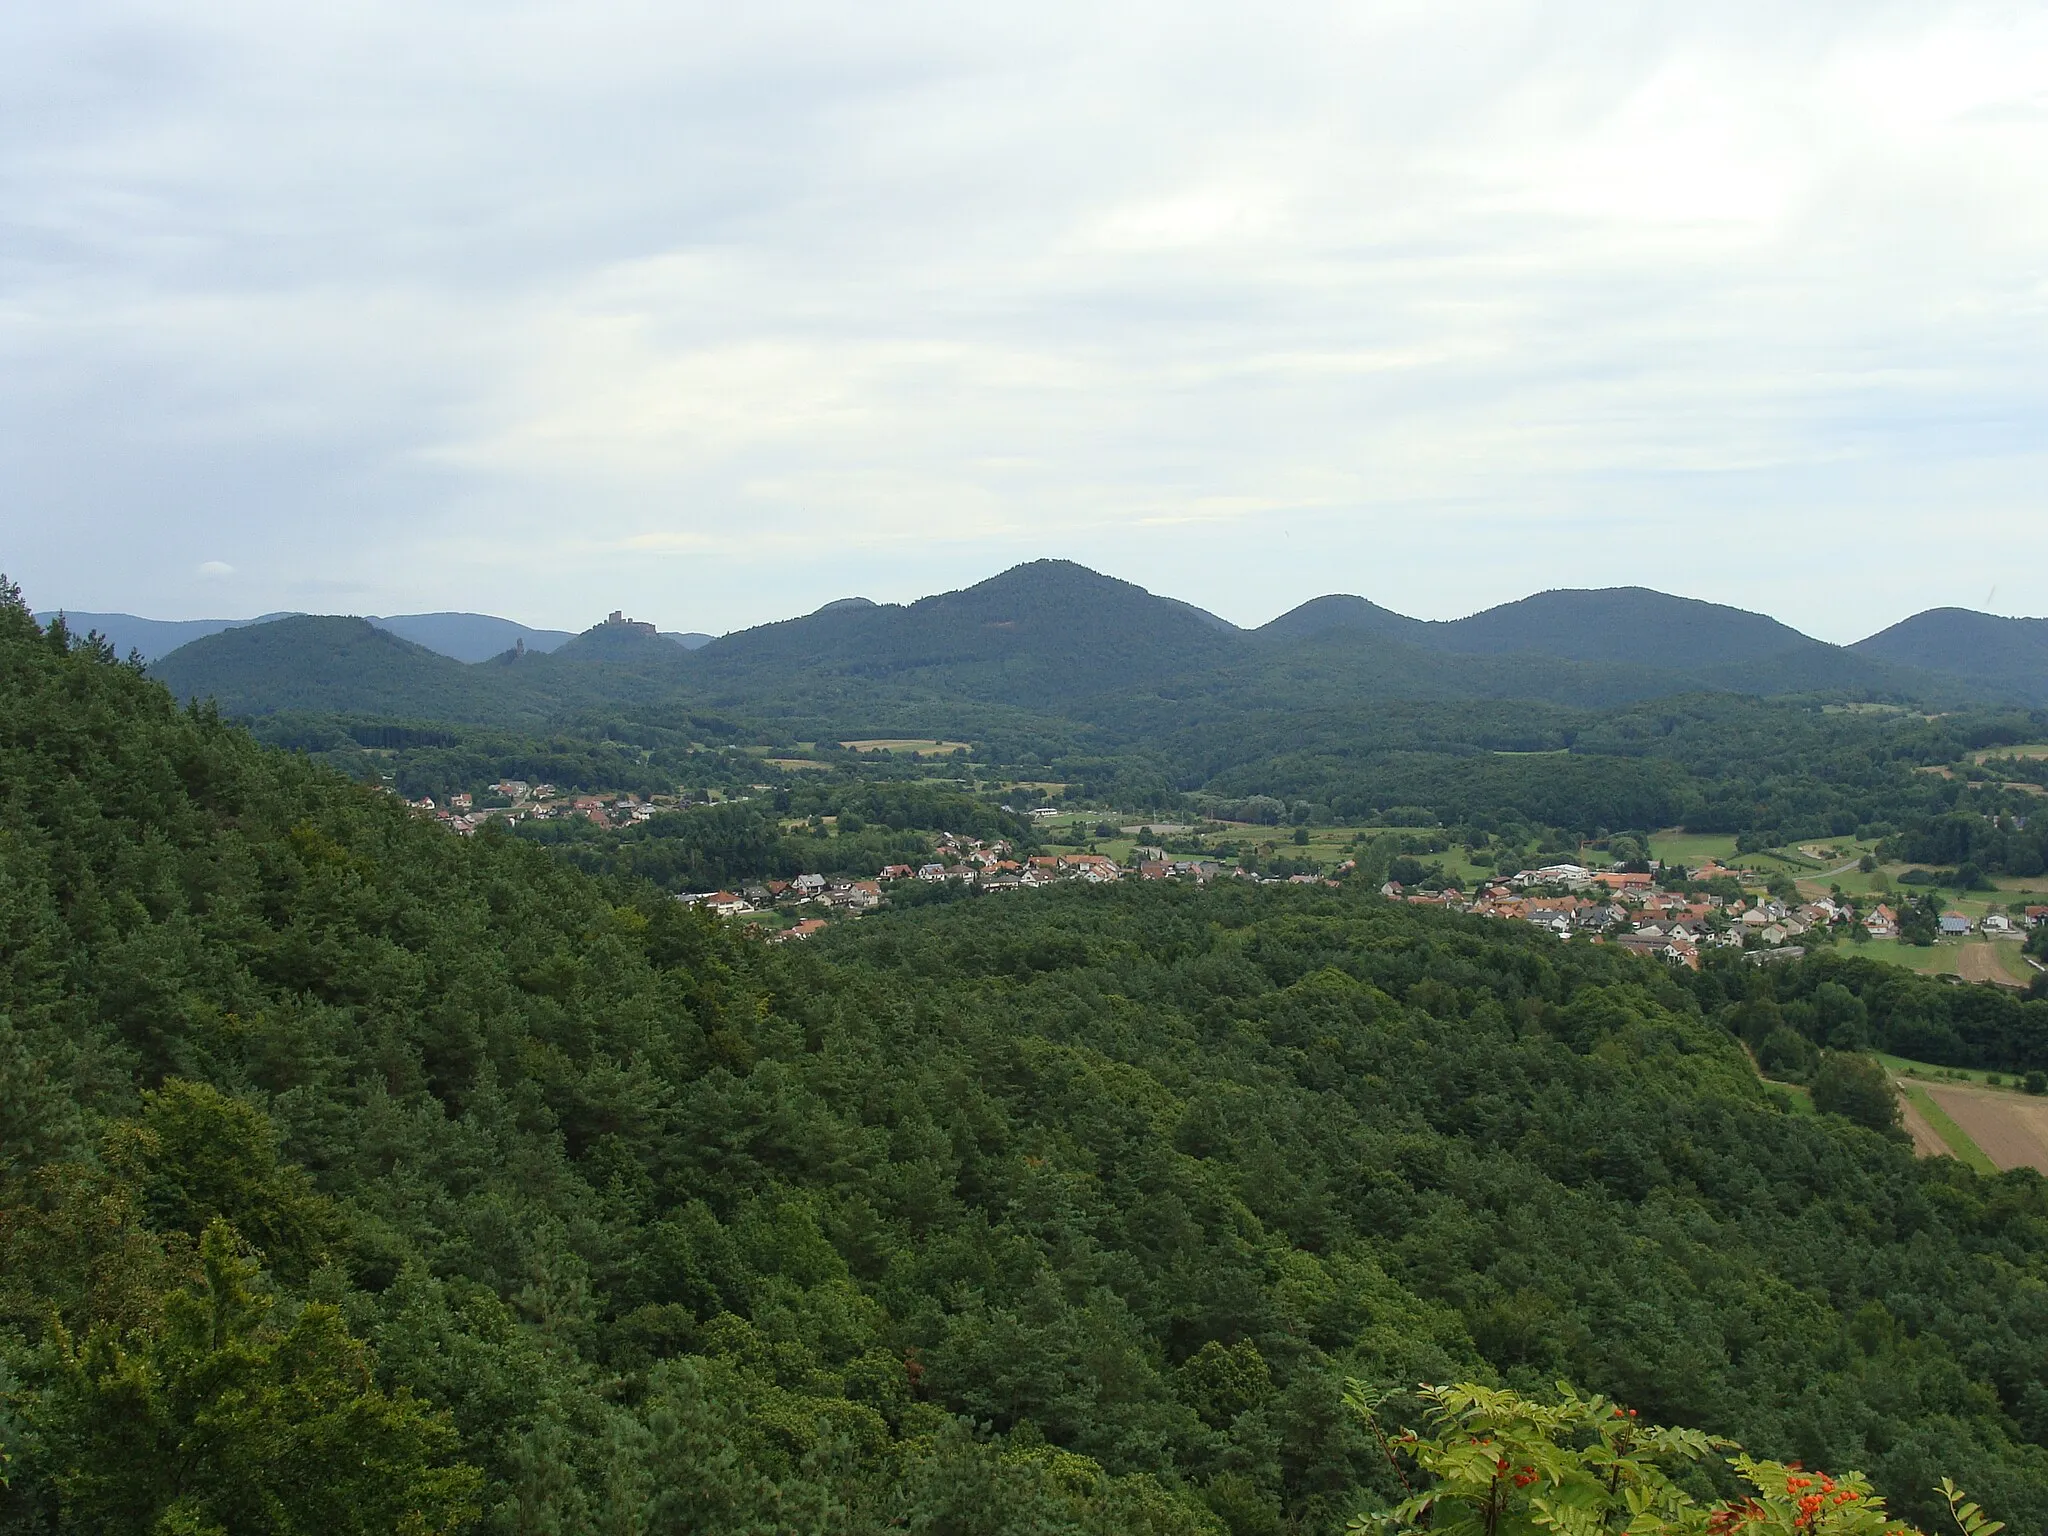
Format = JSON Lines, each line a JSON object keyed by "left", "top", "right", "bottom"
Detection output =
{"left": 0, "top": 0, "right": 2048, "bottom": 641}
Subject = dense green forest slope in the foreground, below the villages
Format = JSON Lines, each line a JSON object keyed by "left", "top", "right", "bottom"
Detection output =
{"left": 12, "top": 581, "right": 2048, "bottom": 1536}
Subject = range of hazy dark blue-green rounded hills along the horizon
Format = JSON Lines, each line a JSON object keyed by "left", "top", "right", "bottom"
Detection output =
{"left": 136, "top": 561, "right": 2048, "bottom": 733}
